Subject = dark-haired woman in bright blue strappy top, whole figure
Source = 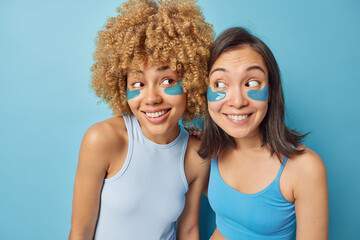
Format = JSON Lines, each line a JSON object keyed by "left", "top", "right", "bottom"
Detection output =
{"left": 199, "top": 28, "right": 328, "bottom": 240}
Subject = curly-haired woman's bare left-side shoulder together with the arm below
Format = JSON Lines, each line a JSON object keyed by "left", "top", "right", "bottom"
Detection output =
{"left": 70, "top": 117, "right": 127, "bottom": 236}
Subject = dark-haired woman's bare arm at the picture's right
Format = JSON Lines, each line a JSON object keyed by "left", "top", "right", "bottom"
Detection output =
{"left": 294, "top": 149, "right": 329, "bottom": 240}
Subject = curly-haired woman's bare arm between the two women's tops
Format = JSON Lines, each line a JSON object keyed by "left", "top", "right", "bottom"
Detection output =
{"left": 177, "top": 137, "right": 209, "bottom": 240}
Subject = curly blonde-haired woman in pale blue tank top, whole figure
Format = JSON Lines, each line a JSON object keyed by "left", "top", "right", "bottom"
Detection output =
{"left": 69, "top": 0, "right": 214, "bottom": 240}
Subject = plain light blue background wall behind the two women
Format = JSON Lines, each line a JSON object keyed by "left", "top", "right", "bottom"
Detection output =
{"left": 0, "top": 0, "right": 360, "bottom": 240}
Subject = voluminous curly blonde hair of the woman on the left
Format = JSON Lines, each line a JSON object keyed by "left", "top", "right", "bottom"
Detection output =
{"left": 91, "top": 0, "right": 214, "bottom": 121}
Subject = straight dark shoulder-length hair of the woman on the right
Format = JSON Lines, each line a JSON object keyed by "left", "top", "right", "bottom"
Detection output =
{"left": 198, "top": 27, "right": 307, "bottom": 162}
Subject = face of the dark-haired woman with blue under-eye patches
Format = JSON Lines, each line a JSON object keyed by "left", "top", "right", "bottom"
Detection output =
{"left": 207, "top": 46, "right": 269, "bottom": 139}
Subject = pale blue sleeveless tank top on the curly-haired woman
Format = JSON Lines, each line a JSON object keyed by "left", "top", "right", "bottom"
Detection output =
{"left": 94, "top": 116, "right": 189, "bottom": 240}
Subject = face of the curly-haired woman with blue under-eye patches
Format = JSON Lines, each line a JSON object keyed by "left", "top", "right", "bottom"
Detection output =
{"left": 127, "top": 63, "right": 186, "bottom": 144}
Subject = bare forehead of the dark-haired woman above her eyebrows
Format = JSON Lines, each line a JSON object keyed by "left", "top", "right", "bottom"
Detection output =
{"left": 210, "top": 46, "right": 267, "bottom": 75}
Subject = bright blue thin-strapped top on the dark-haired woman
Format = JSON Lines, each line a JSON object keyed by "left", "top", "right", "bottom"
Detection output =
{"left": 208, "top": 158, "right": 296, "bottom": 240}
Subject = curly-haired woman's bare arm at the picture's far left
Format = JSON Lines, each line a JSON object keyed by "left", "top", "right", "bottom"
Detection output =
{"left": 69, "top": 124, "right": 119, "bottom": 240}
